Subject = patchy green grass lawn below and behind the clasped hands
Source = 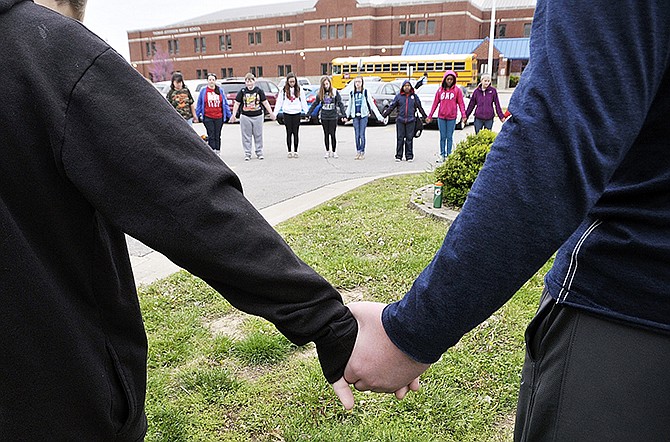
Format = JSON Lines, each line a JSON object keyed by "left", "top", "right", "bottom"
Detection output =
{"left": 140, "top": 174, "right": 548, "bottom": 442}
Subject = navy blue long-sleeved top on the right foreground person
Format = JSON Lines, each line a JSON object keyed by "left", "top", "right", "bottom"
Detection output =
{"left": 383, "top": 0, "right": 670, "bottom": 363}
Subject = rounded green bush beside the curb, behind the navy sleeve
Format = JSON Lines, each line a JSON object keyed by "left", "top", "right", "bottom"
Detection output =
{"left": 435, "top": 129, "right": 496, "bottom": 207}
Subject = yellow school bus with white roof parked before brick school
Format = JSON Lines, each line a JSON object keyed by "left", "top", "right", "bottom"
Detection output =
{"left": 332, "top": 54, "right": 478, "bottom": 89}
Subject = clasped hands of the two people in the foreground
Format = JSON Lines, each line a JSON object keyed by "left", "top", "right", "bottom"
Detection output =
{"left": 338, "top": 302, "right": 430, "bottom": 396}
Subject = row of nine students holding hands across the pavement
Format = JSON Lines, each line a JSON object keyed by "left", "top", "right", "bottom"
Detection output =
{"left": 167, "top": 71, "right": 506, "bottom": 162}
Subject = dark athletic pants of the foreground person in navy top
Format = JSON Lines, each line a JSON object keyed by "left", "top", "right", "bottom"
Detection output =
{"left": 514, "top": 290, "right": 670, "bottom": 442}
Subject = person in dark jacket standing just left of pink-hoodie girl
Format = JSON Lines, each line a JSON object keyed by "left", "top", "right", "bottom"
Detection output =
{"left": 382, "top": 80, "right": 426, "bottom": 163}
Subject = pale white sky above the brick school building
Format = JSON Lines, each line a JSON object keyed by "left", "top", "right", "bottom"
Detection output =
{"left": 84, "top": 0, "right": 290, "bottom": 60}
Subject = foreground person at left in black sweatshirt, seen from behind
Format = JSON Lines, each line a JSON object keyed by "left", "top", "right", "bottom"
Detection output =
{"left": 0, "top": 0, "right": 357, "bottom": 441}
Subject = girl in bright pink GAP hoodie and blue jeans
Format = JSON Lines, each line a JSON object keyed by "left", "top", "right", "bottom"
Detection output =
{"left": 426, "top": 71, "right": 465, "bottom": 163}
